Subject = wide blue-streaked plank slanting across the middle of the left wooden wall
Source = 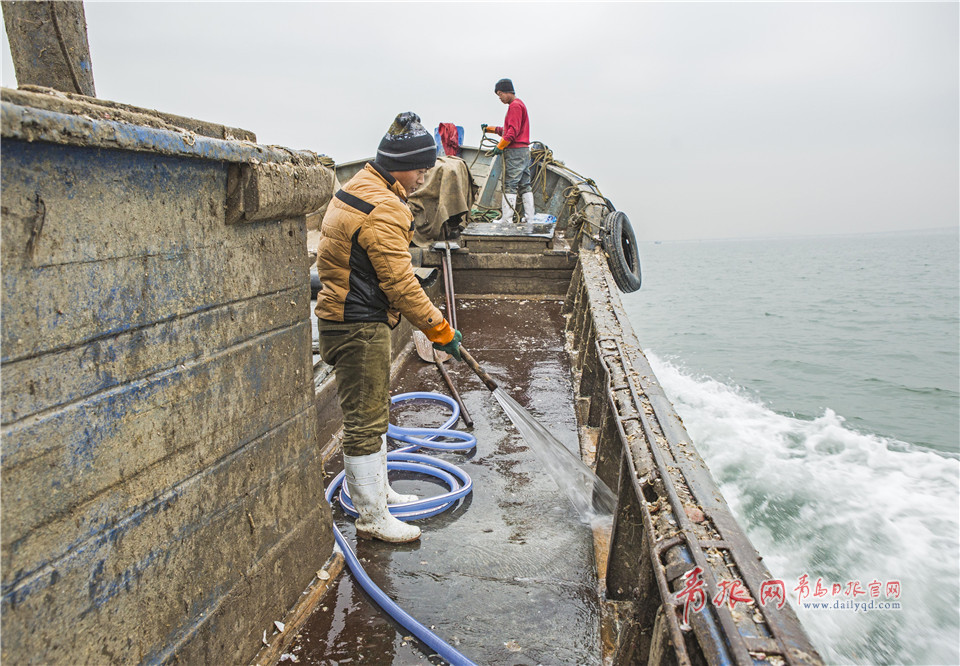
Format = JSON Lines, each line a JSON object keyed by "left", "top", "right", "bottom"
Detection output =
{"left": 0, "top": 323, "right": 313, "bottom": 586}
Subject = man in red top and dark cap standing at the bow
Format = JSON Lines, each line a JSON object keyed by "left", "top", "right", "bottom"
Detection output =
{"left": 480, "top": 79, "right": 534, "bottom": 224}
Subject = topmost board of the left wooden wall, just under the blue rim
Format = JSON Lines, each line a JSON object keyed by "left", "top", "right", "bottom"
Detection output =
{"left": 2, "top": 140, "right": 229, "bottom": 269}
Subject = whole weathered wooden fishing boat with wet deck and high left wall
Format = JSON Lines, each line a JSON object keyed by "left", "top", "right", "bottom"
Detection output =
{"left": 0, "top": 3, "right": 820, "bottom": 666}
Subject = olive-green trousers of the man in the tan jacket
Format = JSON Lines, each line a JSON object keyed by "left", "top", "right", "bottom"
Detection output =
{"left": 318, "top": 319, "right": 390, "bottom": 456}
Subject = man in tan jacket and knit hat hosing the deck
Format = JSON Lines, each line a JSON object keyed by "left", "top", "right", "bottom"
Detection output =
{"left": 316, "top": 112, "right": 461, "bottom": 542}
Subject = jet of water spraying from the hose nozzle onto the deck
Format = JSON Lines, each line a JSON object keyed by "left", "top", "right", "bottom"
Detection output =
{"left": 493, "top": 388, "right": 617, "bottom": 525}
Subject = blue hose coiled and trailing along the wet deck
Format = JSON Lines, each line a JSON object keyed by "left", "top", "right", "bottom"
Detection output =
{"left": 325, "top": 392, "right": 477, "bottom": 666}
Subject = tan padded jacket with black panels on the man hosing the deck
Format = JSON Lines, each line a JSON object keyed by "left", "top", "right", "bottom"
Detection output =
{"left": 316, "top": 163, "right": 453, "bottom": 344}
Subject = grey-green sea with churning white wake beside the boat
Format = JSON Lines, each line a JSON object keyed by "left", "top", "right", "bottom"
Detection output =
{"left": 623, "top": 229, "right": 960, "bottom": 664}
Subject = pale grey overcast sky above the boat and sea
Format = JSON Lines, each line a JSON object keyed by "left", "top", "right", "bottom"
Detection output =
{"left": 2, "top": 1, "right": 960, "bottom": 240}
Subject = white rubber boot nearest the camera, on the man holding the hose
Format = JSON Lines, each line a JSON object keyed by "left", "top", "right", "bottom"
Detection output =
{"left": 343, "top": 451, "right": 420, "bottom": 543}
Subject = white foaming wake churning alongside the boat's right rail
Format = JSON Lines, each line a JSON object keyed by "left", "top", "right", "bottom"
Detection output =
{"left": 648, "top": 353, "right": 960, "bottom": 664}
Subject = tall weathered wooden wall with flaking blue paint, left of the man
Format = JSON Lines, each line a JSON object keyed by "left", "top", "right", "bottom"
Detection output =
{"left": 0, "top": 91, "right": 333, "bottom": 663}
